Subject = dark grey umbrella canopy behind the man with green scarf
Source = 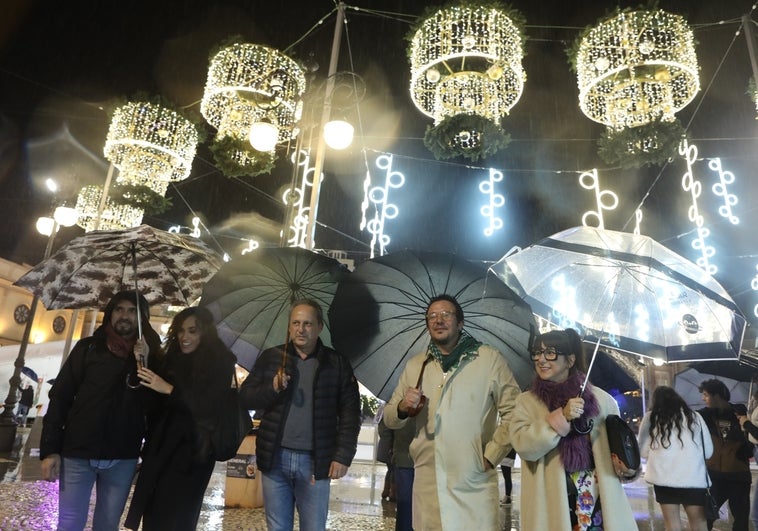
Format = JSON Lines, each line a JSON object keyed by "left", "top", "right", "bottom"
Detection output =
{"left": 329, "top": 251, "right": 537, "bottom": 400}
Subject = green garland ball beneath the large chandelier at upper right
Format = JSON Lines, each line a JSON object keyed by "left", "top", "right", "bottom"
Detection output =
{"left": 597, "top": 120, "right": 685, "bottom": 168}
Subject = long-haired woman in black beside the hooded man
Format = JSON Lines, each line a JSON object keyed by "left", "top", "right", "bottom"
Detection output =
{"left": 124, "top": 307, "right": 237, "bottom": 531}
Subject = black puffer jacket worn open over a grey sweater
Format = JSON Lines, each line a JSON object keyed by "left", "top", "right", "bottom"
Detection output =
{"left": 240, "top": 340, "right": 361, "bottom": 479}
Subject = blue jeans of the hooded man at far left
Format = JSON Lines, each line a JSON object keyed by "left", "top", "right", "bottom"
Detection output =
{"left": 58, "top": 457, "right": 137, "bottom": 531}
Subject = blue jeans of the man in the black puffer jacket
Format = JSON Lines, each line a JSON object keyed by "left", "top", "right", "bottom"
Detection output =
{"left": 262, "top": 448, "right": 329, "bottom": 531}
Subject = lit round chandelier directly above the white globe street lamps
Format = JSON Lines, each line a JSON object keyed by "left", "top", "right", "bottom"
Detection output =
{"left": 205, "top": 44, "right": 305, "bottom": 151}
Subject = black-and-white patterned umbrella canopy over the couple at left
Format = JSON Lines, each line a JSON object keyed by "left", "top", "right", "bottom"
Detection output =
{"left": 14, "top": 225, "right": 222, "bottom": 309}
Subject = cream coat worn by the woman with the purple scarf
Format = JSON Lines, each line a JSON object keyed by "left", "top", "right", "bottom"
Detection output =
{"left": 510, "top": 387, "right": 637, "bottom": 531}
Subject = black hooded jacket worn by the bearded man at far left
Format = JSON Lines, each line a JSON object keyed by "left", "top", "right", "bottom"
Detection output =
{"left": 40, "top": 291, "right": 160, "bottom": 459}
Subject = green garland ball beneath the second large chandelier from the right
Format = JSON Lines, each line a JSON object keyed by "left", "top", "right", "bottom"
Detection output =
{"left": 424, "top": 114, "right": 511, "bottom": 162}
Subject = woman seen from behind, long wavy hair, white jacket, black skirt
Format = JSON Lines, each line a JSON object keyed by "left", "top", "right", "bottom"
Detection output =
{"left": 638, "top": 385, "right": 713, "bottom": 531}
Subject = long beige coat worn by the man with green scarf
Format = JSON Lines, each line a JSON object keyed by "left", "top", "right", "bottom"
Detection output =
{"left": 384, "top": 345, "right": 520, "bottom": 531}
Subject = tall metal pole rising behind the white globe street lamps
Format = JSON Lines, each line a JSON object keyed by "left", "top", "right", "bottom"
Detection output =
{"left": 305, "top": 2, "right": 345, "bottom": 249}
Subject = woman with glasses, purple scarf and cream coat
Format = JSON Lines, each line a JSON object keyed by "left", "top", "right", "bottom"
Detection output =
{"left": 510, "top": 328, "right": 637, "bottom": 531}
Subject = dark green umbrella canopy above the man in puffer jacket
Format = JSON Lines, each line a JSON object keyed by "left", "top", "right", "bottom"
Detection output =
{"left": 200, "top": 247, "right": 347, "bottom": 370}
